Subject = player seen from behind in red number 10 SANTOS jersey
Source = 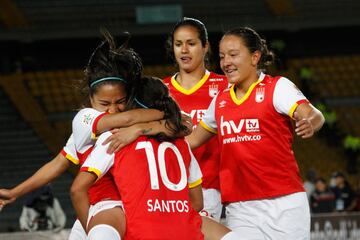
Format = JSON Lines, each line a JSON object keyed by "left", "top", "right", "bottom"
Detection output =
{"left": 71, "top": 77, "right": 238, "bottom": 240}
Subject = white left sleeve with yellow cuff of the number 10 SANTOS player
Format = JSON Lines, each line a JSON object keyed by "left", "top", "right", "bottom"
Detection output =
{"left": 80, "top": 132, "right": 115, "bottom": 178}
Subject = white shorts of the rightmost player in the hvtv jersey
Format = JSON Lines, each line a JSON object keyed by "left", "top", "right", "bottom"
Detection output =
{"left": 225, "top": 192, "right": 310, "bottom": 240}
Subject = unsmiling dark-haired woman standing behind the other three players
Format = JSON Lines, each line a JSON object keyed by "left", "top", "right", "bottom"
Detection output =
{"left": 164, "top": 17, "right": 228, "bottom": 221}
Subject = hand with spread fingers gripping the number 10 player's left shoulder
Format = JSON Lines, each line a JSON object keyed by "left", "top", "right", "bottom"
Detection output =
{"left": 103, "top": 125, "right": 140, "bottom": 154}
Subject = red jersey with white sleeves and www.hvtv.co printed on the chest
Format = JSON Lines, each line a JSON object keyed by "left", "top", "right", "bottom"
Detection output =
{"left": 201, "top": 74, "right": 307, "bottom": 202}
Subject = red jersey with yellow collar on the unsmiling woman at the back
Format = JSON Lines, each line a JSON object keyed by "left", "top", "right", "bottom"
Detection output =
{"left": 164, "top": 71, "right": 228, "bottom": 190}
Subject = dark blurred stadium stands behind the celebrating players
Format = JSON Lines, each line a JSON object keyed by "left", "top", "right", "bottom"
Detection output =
{"left": 0, "top": 0, "right": 360, "bottom": 239}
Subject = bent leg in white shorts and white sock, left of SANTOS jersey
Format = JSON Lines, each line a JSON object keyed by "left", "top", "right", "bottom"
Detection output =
{"left": 87, "top": 201, "right": 126, "bottom": 239}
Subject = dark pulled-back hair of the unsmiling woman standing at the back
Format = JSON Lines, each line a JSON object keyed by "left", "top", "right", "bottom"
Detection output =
{"left": 166, "top": 17, "right": 211, "bottom": 67}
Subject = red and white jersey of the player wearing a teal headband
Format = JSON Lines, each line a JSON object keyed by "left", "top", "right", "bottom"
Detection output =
{"left": 62, "top": 108, "right": 120, "bottom": 205}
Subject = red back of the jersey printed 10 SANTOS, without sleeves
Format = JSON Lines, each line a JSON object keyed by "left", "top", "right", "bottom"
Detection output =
{"left": 112, "top": 137, "right": 203, "bottom": 240}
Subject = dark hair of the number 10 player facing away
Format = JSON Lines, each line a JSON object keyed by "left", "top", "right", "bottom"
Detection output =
{"left": 133, "top": 76, "right": 187, "bottom": 141}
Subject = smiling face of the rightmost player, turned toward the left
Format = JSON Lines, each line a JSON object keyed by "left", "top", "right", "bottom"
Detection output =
{"left": 219, "top": 35, "right": 261, "bottom": 84}
